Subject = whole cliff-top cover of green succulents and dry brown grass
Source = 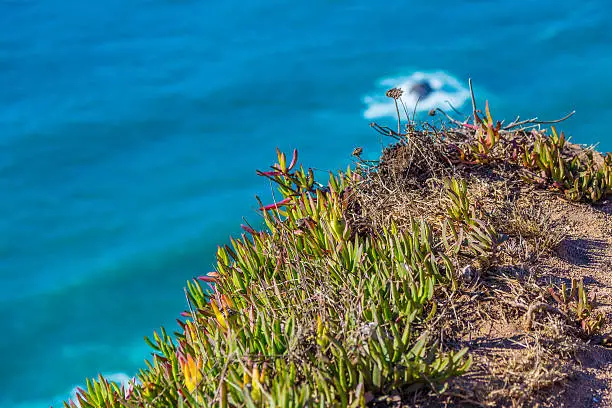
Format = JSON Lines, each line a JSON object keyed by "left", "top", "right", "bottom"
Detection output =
{"left": 65, "top": 84, "right": 612, "bottom": 407}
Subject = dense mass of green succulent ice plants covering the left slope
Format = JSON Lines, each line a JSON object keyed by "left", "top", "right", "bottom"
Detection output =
{"left": 66, "top": 152, "right": 470, "bottom": 407}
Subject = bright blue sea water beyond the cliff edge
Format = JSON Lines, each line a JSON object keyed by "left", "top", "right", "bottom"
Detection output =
{"left": 0, "top": 0, "right": 612, "bottom": 407}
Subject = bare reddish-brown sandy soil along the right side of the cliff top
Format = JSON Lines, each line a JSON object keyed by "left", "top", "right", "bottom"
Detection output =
{"left": 436, "top": 196, "right": 612, "bottom": 408}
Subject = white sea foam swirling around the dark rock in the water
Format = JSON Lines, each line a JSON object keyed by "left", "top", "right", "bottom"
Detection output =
{"left": 363, "top": 71, "right": 470, "bottom": 119}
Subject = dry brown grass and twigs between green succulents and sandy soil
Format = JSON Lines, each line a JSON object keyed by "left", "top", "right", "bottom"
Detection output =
{"left": 347, "top": 103, "right": 603, "bottom": 407}
